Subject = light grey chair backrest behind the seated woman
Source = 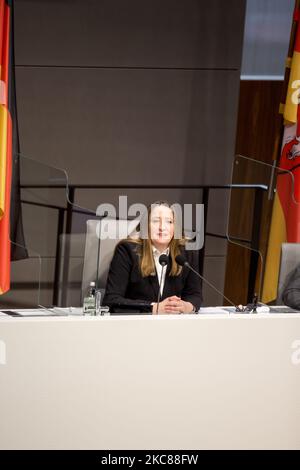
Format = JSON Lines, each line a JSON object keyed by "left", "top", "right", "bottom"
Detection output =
{"left": 81, "top": 217, "right": 139, "bottom": 296}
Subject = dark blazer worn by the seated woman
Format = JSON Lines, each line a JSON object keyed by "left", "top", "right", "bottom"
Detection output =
{"left": 103, "top": 241, "right": 202, "bottom": 312}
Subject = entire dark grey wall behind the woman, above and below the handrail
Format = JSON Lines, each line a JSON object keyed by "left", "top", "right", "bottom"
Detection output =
{"left": 4, "top": 0, "right": 246, "bottom": 304}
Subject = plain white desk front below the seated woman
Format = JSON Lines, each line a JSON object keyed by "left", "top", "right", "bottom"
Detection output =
{"left": 0, "top": 314, "right": 300, "bottom": 449}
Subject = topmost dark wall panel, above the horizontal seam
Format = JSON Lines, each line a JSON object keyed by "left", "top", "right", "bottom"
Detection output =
{"left": 15, "top": 0, "right": 245, "bottom": 69}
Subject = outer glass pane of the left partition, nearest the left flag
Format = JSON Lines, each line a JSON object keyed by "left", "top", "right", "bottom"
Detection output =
{"left": 0, "top": 155, "right": 68, "bottom": 309}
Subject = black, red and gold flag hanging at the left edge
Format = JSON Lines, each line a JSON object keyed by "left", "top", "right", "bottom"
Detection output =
{"left": 0, "top": 0, "right": 27, "bottom": 294}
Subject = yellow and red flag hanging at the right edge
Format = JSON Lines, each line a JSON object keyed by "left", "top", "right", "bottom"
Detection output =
{"left": 262, "top": 0, "right": 300, "bottom": 302}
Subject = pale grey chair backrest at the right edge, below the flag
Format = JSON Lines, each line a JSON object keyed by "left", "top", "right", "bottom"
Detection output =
{"left": 277, "top": 243, "right": 300, "bottom": 305}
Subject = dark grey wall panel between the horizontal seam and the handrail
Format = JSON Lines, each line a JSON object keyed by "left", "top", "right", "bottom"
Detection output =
{"left": 17, "top": 67, "right": 239, "bottom": 184}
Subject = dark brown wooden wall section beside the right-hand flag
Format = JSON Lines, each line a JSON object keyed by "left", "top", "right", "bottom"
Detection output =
{"left": 224, "top": 81, "right": 283, "bottom": 303}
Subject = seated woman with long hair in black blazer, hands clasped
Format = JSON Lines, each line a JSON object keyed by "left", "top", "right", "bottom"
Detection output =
{"left": 103, "top": 201, "right": 202, "bottom": 314}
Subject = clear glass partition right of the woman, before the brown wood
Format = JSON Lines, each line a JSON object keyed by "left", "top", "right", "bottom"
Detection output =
{"left": 227, "top": 155, "right": 298, "bottom": 302}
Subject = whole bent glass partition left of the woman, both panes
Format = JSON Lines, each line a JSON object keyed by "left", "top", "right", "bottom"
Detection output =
{"left": 14, "top": 155, "right": 103, "bottom": 314}
